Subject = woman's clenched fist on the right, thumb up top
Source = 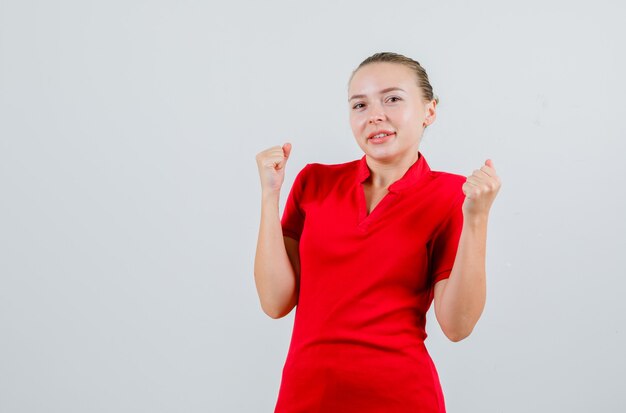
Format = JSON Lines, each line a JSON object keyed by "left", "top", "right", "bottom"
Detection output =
{"left": 463, "top": 159, "right": 500, "bottom": 218}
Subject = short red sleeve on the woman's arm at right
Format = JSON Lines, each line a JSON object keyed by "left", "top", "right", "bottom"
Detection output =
{"left": 430, "top": 194, "right": 465, "bottom": 285}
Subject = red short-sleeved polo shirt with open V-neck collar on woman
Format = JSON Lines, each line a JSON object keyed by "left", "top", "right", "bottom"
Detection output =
{"left": 275, "top": 153, "right": 465, "bottom": 413}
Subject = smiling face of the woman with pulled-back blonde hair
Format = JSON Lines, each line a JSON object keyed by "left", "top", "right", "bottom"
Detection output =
{"left": 348, "top": 62, "right": 436, "bottom": 162}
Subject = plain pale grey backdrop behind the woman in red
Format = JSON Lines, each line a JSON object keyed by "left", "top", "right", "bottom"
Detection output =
{"left": 0, "top": 0, "right": 626, "bottom": 413}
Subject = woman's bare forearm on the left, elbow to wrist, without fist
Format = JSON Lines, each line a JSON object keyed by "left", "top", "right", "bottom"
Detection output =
{"left": 254, "top": 192, "right": 296, "bottom": 318}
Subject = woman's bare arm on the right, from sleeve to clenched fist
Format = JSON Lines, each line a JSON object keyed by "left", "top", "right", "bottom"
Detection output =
{"left": 434, "top": 160, "right": 501, "bottom": 342}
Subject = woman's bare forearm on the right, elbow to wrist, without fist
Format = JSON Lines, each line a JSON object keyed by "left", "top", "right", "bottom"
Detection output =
{"left": 435, "top": 216, "right": 488, "bottom": 341}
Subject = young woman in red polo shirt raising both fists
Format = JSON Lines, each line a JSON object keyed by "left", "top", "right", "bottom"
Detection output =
{"left": 254, "top": 53, "right": 500, "bottom": 413}
